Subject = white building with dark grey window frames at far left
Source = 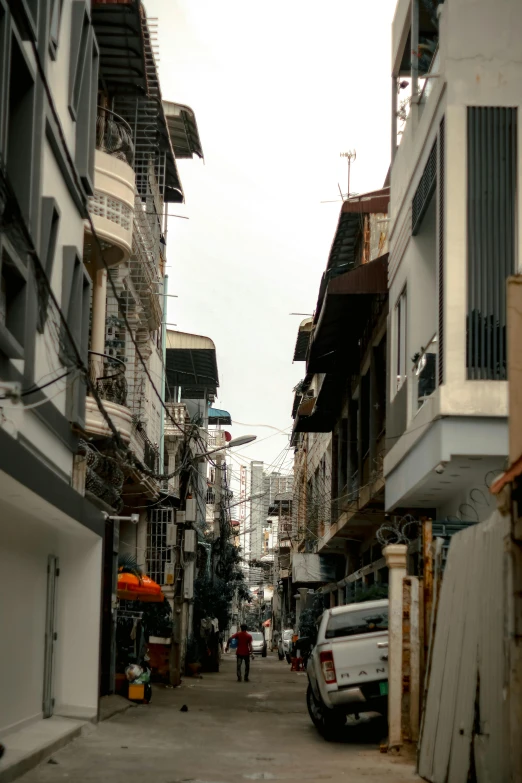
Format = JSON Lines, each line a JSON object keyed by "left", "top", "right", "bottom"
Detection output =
{"left": 0, "top": 0, "right": 104, "bottom": 749}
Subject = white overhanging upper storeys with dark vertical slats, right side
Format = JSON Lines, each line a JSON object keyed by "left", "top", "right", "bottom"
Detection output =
{"left": 384, "top": 0, "right": 522, "bottom": 521}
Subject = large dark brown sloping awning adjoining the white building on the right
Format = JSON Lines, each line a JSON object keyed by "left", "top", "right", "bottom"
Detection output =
{"left": 307, "top": 254, "right": 388, "bottom": 373}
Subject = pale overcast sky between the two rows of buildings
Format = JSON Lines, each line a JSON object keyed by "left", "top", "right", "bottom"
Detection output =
{"left": 145, "top": 0, "right": 395, "bottom": 474}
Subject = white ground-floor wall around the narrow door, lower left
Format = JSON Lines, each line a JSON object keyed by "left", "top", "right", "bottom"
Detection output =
{"left": 0, "top": 495, "right": 102, "bottom": 735}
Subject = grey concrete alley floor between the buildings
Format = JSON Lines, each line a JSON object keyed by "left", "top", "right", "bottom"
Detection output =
{"left": 19, "top": 655, "right": 419, "bottom": 783}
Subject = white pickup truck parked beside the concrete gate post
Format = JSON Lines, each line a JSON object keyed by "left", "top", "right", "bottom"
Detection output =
{"left": 306, "top": 600, "right": 388, "bottom": 739}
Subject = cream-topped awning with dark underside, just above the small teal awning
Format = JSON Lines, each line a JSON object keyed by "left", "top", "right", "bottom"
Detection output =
{"left": 166, "top": 330, "right": 219, "bottom": 400}
